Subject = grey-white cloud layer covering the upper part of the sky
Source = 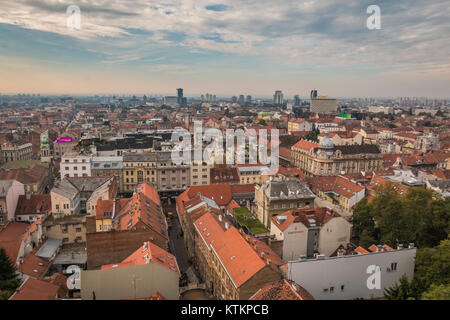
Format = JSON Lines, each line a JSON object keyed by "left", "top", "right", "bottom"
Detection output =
{"left": 0, "top": 0, "right": 450, "bottom": 94}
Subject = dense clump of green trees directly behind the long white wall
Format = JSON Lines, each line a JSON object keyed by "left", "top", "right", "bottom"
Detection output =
{"left": 352, "top": 183, "right": 450, "bottom": 248}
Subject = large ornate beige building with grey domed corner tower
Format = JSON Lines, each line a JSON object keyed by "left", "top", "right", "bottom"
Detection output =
{"left": 291, "top": 135, "right": 383, "bottom": 176}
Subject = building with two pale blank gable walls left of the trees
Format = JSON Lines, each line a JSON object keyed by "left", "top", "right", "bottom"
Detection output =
{"left": 270, "top": 208, "right": 351, "bottom": 261}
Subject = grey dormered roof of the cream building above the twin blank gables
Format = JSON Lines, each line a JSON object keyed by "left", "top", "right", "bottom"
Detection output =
{"left": 263, "top": 180, "right": 316, "bottom": 200}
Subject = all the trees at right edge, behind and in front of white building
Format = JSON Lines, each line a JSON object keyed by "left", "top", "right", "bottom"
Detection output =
{"left": 352, "top": 184, "right": 450, "bottom": 300}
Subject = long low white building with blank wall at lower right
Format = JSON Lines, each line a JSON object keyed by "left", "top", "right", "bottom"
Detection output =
{"left": 287, "top": 245, "right": 416, "bottom": 300}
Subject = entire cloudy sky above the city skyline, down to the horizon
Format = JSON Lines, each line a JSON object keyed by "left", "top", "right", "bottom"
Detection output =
{"left": 0, "top": 0, "right": 450, "bottom": 99}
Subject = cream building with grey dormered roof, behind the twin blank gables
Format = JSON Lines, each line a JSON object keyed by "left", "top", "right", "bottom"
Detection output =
{"left": 255, "top": 178, "right": 316, "bottom": 229}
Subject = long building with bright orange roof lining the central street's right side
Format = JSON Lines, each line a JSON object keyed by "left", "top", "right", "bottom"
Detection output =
{"left": 194, "top": 213, "right": 282, "bottom": 300}
